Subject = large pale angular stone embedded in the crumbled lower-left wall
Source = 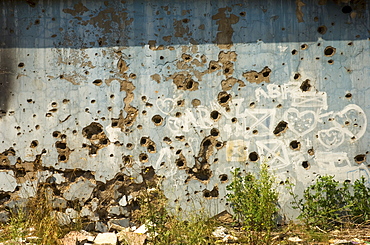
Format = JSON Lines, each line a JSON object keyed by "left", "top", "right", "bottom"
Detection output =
{"left": 63, "top": 177, "right": 96, "bottom": 203}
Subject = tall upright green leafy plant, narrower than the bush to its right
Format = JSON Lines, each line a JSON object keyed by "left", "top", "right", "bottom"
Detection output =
{"left": 227, "top": 164, "right": 278, "bottom": 244}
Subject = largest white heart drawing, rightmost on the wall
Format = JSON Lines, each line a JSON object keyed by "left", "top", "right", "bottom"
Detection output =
{"left": 332, "top": 104, "right": 367, "bottom": 139}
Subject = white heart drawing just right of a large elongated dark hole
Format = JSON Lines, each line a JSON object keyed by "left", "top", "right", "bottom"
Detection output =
{"left": 284, "top": 108, "right": 317, "bottom": 136}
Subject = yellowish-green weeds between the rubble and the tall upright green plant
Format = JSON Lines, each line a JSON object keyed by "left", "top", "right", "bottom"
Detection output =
{"left": 134, "top": 188, "right": 216, "bottom": 245}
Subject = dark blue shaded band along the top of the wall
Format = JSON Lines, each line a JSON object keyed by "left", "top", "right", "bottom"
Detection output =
{"left": 0, "top": 0, "right": 370, "bottom": 49}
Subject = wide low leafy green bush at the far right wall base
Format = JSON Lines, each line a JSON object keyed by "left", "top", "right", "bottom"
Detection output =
{"left": 290, "top": 176, "right": 370, "bottom": 230}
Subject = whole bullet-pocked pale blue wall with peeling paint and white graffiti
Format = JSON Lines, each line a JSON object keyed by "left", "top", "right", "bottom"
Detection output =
{"left": 0, "top": 0, "right": 370, "bottom": 230}
